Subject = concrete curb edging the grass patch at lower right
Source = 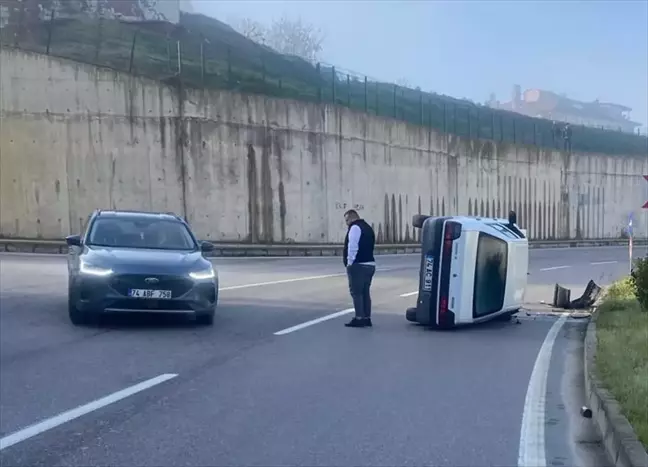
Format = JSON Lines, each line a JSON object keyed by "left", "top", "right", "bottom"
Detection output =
{"left": 584, "top": 312, "right": 648, "bottom": 467}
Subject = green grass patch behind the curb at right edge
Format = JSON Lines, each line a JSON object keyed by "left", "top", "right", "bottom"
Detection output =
{"left": 596, "top": 279, "right": 648, "bottom": 449}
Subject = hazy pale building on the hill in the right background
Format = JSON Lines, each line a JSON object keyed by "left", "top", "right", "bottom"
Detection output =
{"left": 487, "top": 85, "right": 641, "bottom": 133}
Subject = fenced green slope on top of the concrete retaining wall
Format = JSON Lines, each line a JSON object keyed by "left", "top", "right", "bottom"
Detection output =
{"left": 0, "top": 9, "right": 648, "bottom": 154}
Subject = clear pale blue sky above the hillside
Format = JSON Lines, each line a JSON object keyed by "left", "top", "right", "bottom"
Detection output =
{"left": 190, "top": 0, "right": 648, "bottom": 132}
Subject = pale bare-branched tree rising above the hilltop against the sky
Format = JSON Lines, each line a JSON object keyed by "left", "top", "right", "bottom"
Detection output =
{"left": 238, "top": 16, "right": 324, "bottom": 62}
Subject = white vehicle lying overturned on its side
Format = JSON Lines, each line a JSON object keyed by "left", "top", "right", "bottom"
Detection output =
{"left": 406, "top": 212, "right": 529, "bottom": 328}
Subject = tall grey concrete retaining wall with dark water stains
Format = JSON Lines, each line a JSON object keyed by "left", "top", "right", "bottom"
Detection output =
{"left": 0, "top": 48, "right": 648, "bottom": 243}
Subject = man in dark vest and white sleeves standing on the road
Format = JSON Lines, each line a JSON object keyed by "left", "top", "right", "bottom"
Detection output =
{"left": 344, "top": 209, "right": 376, "bottom": 328}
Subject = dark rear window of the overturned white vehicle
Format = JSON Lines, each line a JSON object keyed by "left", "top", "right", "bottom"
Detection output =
{"left": 473, "top": 232, "right": 508, "bottom": 318}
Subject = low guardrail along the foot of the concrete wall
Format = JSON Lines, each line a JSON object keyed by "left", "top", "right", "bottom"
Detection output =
{"left": 0, "top": 238, "right": 648, "bottom": 257}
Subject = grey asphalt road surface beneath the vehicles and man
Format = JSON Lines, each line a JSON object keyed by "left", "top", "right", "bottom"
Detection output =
{"left": 0, "top": 248, "right": 643, "bottom": 467}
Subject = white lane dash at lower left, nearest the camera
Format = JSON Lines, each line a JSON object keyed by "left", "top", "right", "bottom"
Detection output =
{"left": 0, "top": 373, "right": 178, "bottom": 451}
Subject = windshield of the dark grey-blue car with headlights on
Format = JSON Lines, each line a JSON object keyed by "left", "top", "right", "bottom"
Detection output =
{"left": 86, "top": 217, "right": 197, "bottom": 250}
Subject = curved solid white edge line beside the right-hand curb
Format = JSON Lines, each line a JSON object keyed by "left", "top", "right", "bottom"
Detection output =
{"left": 518, "top": 315, "right": 567, "bottom": 467}
